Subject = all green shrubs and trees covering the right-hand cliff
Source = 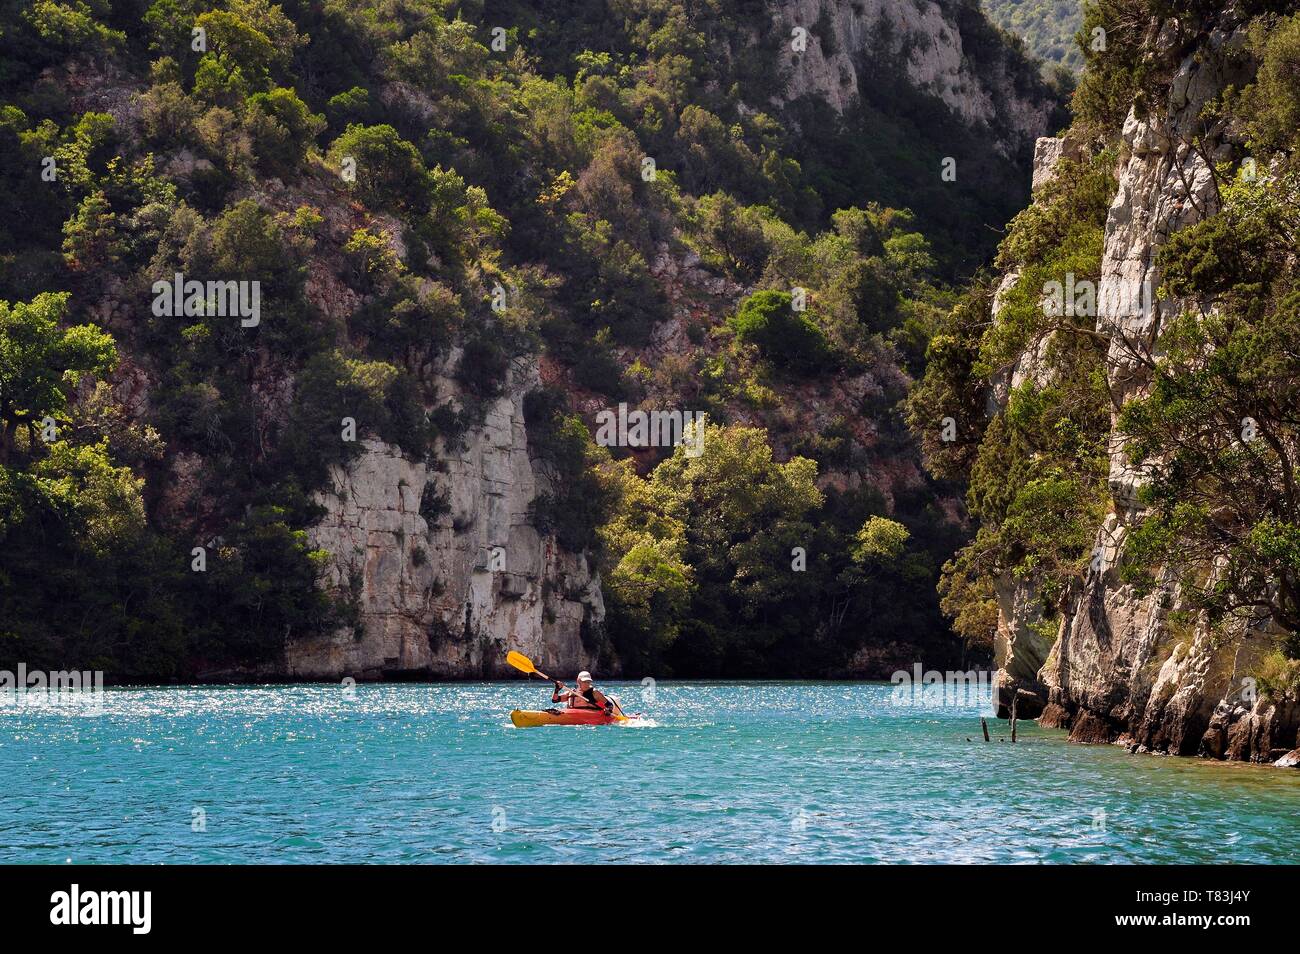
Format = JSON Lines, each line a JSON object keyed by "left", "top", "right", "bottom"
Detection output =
{"left": 909, "top": 0, "right": 1300, "bottom": 658}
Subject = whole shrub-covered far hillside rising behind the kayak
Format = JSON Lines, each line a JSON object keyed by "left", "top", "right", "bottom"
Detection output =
{"left": 0, "top": 0, "right": 1053, "bottom": 680}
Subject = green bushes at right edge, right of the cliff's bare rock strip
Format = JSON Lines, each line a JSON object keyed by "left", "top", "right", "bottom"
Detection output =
{"left": 1119, "top": 167, "right": 1300, "bottom": 658}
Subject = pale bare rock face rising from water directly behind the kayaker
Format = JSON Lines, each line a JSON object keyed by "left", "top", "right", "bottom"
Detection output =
{"left": 286, "top": 355, "right": 611, "bottom": 678}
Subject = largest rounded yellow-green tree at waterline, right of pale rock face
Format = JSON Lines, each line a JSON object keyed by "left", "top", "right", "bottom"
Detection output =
{"left": 605, "top": 425, "right": 824, "bottom": 673}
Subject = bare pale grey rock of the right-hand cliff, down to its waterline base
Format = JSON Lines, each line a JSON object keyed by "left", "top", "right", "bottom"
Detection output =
{"left": 996, "top": 14, "right": 1300, "bottom": 764}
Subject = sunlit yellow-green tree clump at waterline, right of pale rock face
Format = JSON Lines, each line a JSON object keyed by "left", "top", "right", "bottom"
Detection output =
{"left": 602, "top": 425, "right": 954, "bottom": 676}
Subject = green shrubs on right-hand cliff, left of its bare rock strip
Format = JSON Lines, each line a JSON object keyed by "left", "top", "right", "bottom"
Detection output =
{"left": 909, "top": 153, "right": 1114, "bottom": 645}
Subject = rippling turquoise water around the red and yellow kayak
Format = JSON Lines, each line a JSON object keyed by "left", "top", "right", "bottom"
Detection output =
{"left": 0, "top": 682, "right": 1300, "bottom": 863}
